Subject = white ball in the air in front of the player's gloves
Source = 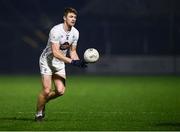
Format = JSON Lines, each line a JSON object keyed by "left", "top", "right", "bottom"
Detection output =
{"left": 84, "top": 48, "right": 99, "bottom": 63}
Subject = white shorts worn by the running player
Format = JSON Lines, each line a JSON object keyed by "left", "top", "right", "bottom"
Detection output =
{"left": 39, "top": 57, "right": 66, "bottom": 78}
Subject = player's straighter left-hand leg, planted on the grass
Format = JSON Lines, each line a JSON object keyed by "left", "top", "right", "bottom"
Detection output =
{"left": 36, "top": 75, "right": 52, "bottom": 118}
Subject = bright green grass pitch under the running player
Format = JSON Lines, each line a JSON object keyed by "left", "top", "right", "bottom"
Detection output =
{"left": 0, "top": 76, "right": 180, "bottom": 131}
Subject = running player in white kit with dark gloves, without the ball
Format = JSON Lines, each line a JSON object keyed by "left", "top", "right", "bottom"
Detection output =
{"left": 35, "top": 7, "right": 87, "bottom": 121}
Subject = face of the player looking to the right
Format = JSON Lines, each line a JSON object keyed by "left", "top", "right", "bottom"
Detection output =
{"left": 64, "top": 13, "right": 77, "bottom": 26}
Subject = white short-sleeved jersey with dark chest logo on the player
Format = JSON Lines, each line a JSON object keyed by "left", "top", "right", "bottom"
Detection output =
{"left": 40, "top": 23, "right": 79, "bottom": 71}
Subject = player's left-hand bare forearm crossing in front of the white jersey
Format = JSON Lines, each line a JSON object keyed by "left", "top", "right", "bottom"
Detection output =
{"left": 51, "top": 43, "right": 72, "bottom": 63}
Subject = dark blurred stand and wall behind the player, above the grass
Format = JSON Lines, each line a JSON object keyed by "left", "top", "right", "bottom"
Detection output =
{"left": 0, "top": 0, "right": 180, "bottom": 75}
